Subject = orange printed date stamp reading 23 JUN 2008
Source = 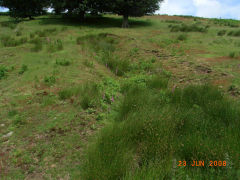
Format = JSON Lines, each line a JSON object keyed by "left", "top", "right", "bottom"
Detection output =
{"left": 177, "top": 161, "right": 227, "bottom": 167}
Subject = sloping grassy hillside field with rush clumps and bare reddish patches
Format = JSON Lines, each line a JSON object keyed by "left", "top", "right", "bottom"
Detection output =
{"left": 0, "top": 15, "right": 240, "bottom": 180}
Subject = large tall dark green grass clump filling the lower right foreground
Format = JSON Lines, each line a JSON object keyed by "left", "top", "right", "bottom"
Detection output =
{"left": 82, "top": 83, "right": 240, "bottom": 179}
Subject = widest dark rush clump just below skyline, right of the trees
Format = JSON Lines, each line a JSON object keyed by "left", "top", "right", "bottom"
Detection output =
{"left": 169, "top": 24, "right": 208, "bottom": 33}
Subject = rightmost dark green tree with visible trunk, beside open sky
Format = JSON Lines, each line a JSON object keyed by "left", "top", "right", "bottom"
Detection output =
{"left": 94, "top": 0, "right": 163, "bottom": 28}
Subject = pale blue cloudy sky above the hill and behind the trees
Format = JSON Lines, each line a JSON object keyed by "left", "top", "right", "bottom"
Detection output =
{"left": 0, "top": 0, "right": 240, "bottom": 20}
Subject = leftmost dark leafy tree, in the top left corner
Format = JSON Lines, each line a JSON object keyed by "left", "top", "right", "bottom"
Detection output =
{"left": 0, "top": 0, "right": 48, "bottom": 19}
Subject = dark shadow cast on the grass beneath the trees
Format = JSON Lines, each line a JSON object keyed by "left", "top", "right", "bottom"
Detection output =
{"left": 39, "top": 16, "right": 152, "bottom": 28}
